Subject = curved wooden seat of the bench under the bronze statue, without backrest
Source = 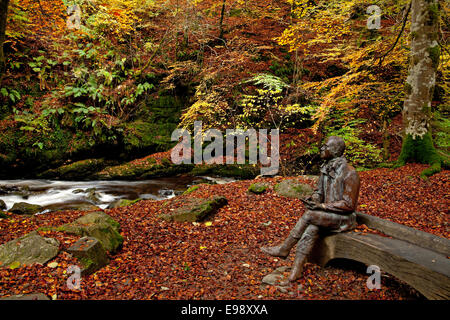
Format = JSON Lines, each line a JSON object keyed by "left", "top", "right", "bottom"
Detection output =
{"left": 308, "top": 232, "right": 450, "bottom": 300}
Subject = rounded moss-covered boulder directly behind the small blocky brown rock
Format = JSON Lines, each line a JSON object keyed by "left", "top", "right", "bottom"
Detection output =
{"left": 57, "top": 211, "right": 123, "bottom": 253}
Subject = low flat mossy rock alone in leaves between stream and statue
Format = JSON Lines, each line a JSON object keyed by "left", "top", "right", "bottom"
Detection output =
{"left": 159, "top": 196, "right": 228, "bottom": 222}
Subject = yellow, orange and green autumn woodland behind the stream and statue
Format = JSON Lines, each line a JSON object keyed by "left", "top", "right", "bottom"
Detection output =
{"left": 0, "top": 0, "right": 449, "bottom": 177}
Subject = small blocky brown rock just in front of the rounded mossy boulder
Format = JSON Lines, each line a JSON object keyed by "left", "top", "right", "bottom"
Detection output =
{"left": 67, "top": 237, "right": 109, "bottom": 275}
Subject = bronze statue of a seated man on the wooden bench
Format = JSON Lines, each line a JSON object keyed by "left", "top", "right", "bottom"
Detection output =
{"left": 261, "top": 136, "right": 359, "bottom": 281}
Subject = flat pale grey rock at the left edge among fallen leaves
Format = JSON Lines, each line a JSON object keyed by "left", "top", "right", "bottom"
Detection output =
{"left": 0, "top": 231, "right": 59, "bottom": 267}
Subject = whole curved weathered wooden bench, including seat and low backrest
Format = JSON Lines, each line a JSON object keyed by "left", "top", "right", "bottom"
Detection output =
{"left": 308, "top": 212, "right": 450, "bottom": 300}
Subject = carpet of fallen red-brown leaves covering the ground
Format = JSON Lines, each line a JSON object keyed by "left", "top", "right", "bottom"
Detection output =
{"left": 0, "top": 164, "right": 449, "bottom": 300}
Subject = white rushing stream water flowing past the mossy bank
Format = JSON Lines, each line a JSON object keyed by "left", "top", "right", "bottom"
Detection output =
{"left": 0, "top": 176, "right": 233, "bottom": 213}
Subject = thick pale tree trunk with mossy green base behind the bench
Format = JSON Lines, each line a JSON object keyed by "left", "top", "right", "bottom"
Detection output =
{"left": 398, "top": 0, "right": 441, "bottom": 176}
